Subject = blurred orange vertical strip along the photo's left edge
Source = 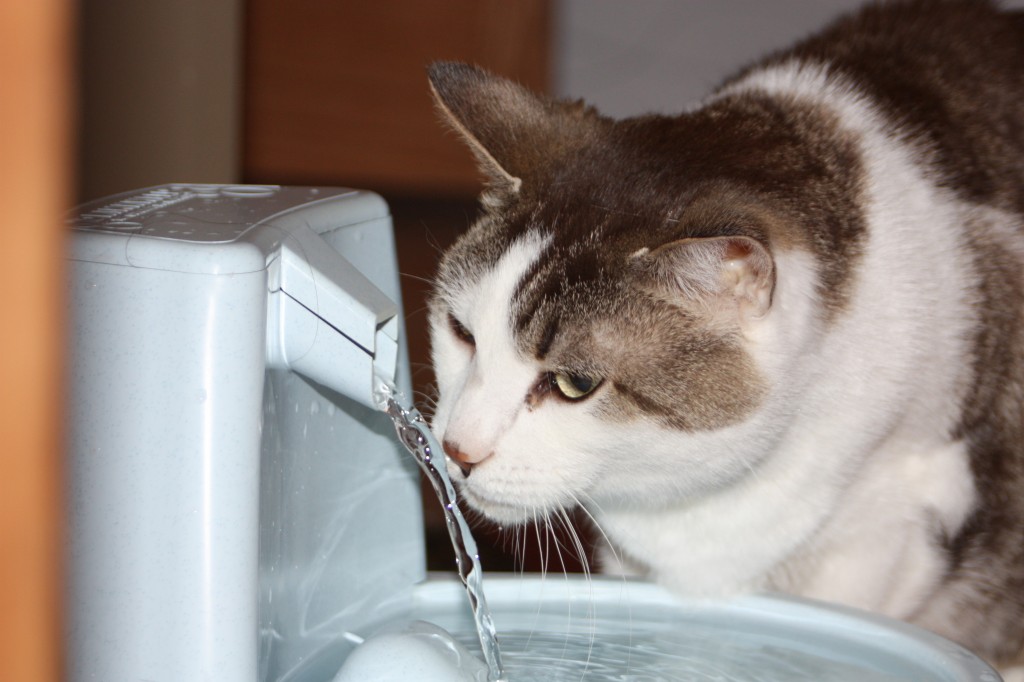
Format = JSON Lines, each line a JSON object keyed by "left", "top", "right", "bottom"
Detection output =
{"left": 0, "top": 0, "right": 72, "bottom": 682}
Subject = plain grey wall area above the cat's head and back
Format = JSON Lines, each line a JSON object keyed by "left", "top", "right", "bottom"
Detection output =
{"left": 553, "top": 0, "right": 1024, "bottom": 117}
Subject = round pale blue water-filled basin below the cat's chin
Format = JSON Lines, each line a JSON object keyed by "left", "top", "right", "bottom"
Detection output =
{"left": 331, "top": 574, "right": 999, "bottom": 682}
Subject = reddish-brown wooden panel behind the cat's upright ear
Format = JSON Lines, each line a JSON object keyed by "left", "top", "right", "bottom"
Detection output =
{"left": 244, "top": 0, "right": 551, "bottom": 197}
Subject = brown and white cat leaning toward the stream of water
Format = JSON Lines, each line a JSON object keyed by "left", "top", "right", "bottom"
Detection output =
{"left": 421, "top": 1, "right": 1024, "bottom": 667}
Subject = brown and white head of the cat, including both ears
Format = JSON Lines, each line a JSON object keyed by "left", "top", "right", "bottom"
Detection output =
{"left": 421, "top": 63, "right": 839, "bottom": 523}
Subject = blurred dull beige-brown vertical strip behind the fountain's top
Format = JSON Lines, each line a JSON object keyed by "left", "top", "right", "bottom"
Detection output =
{"left": 78, "top": 0, "right": 243, "bottom": 200}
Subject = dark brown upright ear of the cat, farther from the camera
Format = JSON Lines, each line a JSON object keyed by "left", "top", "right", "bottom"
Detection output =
{"left": 428, "top": 61, "right": 600, "bottom": 199}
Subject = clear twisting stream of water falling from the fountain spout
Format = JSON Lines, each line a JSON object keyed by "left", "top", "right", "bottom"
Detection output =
{"left": 377, "top": 385, "right": 505, "bottom": 682}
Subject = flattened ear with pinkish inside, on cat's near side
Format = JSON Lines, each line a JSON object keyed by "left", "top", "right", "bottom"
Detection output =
{"left": 634, "top": 237, "right": 775, "bottom": 321}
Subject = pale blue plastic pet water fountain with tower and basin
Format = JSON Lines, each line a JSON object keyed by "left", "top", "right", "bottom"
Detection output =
{"left": 66, "top": 184, "right": 998, "bottom": 682}
